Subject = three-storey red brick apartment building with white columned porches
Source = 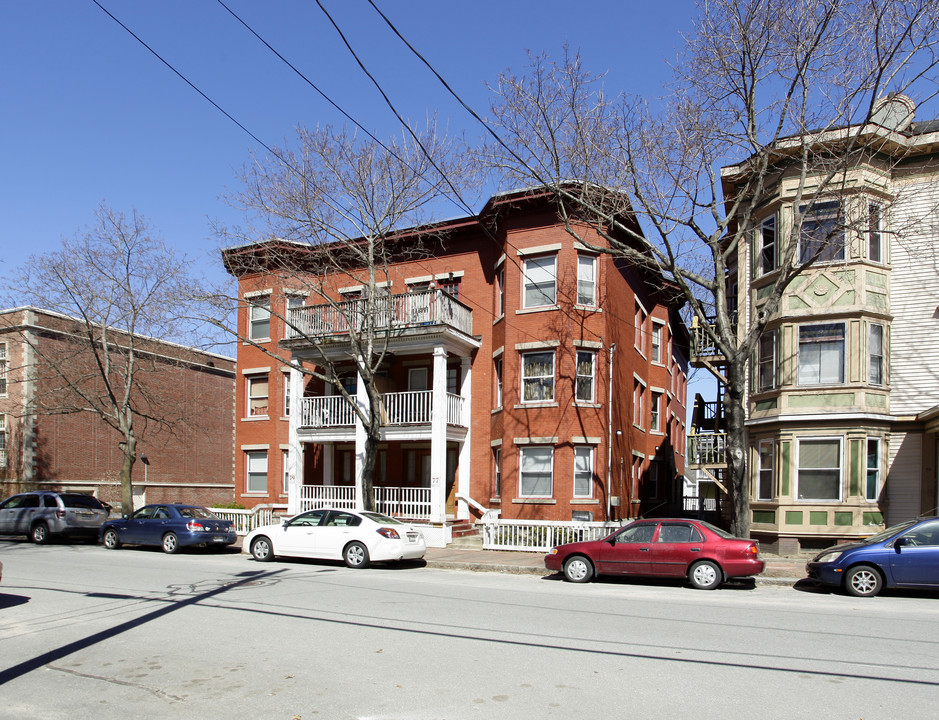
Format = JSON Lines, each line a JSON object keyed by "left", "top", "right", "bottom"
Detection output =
{"left": 223, "top": 186, "right": 688, "bottom": 536}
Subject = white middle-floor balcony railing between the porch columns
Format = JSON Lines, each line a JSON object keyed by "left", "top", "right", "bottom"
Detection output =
{"left": 300, "top": 390, "right": 466, "bottom": 428}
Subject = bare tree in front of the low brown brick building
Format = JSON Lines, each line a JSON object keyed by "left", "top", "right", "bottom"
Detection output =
{"left": 0, "top": 203, "right": 206, "bottom": 514}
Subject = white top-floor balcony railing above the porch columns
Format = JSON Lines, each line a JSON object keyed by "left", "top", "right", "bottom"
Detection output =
{"left": 287, "top": 289, "right": 473, "bottom": 338}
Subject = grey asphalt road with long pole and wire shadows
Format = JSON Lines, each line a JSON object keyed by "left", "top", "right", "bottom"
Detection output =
{"left": 0, "top": 540, "right": 939, "bottom": 720}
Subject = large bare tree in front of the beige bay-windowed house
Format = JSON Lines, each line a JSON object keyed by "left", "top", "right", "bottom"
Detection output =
{"left": 483, "top": 0, "right": 939, "bottom": 535}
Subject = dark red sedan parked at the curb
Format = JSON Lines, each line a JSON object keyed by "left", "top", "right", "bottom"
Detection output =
{"left": 544, "top": 519, "right": 763, "bottom": 590}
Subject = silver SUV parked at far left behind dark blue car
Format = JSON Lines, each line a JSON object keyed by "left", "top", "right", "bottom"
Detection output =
{"left": 0, "top": 492, "right": 110, "bottom": 544}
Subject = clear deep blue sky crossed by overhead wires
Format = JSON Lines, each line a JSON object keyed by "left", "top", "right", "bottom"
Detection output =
{"left": 0, "top": 0, "right": 695, "bottom": 275}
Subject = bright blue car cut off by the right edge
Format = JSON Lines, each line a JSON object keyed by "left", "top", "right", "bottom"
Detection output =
{"left": 805, "top": 517, "right": 939, "bottom": 597}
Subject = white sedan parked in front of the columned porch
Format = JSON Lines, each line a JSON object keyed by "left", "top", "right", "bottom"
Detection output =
{"left": 243, "top": 508, "right": 427, "bottom": 568}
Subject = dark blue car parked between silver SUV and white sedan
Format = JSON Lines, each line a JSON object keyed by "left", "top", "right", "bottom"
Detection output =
{"left": 99, "top": 504, "right": 237, "bottom": 553}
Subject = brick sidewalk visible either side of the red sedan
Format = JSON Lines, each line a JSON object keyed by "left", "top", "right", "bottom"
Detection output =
{"left": 424, "top": 547, "right": 808, "bottom": 585}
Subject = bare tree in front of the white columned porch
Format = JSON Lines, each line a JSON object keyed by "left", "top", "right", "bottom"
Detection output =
{"left": 218, "top": 123, "right": 468, "bottom": 510}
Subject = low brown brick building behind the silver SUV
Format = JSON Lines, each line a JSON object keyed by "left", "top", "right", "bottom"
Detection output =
{"left": 0, "top": 307, "right": 235, "bottom": 507}
